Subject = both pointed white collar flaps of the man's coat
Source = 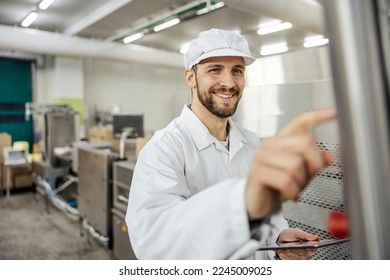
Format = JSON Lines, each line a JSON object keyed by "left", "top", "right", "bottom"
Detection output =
{"left": 181, "top": 104, "right": 248, "bottom": 153}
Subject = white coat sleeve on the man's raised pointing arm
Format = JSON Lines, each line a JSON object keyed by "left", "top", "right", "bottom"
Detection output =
{"left": 126, "top": 137, "right": 250, "bottom": 259}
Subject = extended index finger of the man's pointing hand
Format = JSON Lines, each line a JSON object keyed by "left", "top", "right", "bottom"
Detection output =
{"left": 279, "top": 108, "right": 337, "bottom": 135}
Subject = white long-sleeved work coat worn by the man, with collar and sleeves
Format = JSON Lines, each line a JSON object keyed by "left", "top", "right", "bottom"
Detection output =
{"left": 126, "top": 105, "right": 288, "bottom": 259}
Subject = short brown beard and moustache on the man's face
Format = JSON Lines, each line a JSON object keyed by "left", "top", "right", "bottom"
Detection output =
{"left": 197, "top": 76, "right": 240, "bottom": 119}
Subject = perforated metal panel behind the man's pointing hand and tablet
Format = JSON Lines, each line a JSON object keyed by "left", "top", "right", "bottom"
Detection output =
{"left": 284, "top": 142, "right": 352, "bottom": 260}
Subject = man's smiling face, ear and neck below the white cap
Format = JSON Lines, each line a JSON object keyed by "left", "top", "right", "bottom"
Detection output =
{"left": 185, "top": 56, "right": 245, "bottom": 141}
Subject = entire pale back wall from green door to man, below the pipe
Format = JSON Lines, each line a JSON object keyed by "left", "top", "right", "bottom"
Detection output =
{"left": 34, "top": 57, "right": 190, "bottom": 135}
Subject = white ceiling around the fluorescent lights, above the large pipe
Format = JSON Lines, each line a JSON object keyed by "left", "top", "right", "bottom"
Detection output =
{"left": 0, "top": 0, "right": 319, "bottom": 61}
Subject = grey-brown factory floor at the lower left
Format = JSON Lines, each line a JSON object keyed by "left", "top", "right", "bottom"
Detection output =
{"left": 0, "top": 189, "right": 114, "bottom": 260}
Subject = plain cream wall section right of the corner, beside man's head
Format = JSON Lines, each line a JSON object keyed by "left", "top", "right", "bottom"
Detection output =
{"left": 84, "top": 59, "right": 190, "bottom": 135}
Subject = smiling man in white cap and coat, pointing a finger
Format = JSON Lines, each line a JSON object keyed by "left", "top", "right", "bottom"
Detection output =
{"left": 126, "top": 29, "right": 335, "bottom": 259}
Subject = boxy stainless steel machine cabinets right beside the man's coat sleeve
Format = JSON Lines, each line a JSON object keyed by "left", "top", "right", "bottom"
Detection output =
{"left": 77, "top": 138, "right": 139, "bottom": 260}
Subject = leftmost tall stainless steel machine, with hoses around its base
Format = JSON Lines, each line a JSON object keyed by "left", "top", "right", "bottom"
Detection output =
{"left": 25, "top": 103, "right": 79, "bottom": 214}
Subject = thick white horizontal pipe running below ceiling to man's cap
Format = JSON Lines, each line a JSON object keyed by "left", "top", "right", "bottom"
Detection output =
{"left": 0, "top": 25, "right": 184, "bottom": 68}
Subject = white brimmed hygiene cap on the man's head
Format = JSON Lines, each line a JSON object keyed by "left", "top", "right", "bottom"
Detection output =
{"left": 184, "top": 28, "right": 255, "bottom": 68}
